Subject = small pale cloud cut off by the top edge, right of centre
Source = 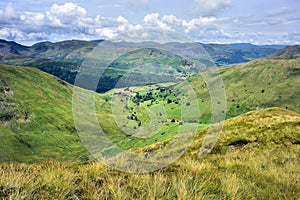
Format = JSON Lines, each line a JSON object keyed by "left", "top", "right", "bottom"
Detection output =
{"left": 195, "top": 0, "right": 233, "bottom": 16}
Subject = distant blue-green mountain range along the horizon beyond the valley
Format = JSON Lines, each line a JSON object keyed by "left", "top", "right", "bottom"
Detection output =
{"left": 0, "top": 40, "right": 288, "bottom": 92}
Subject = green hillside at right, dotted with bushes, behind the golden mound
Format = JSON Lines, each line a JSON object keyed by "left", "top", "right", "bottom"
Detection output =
{"left": 189, "top": 59, "right": 300, "bottom": 123}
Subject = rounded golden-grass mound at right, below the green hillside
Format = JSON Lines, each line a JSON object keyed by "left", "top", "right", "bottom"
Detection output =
{"left": 188, "top": 108, "right": 300, "bottom": 155}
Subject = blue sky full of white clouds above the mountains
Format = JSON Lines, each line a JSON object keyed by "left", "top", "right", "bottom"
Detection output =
{"left": 0, "top": 0, "right": 300, "bottom": 44}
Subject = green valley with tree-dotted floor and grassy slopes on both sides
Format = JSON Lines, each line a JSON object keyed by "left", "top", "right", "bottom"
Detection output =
{"left": 0, "top": 45, "right": 300, "bottom": 162}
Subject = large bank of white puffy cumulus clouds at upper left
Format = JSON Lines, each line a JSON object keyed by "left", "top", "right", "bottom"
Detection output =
{"left": 0, "top": 3, "right": 136, "bottom": 41}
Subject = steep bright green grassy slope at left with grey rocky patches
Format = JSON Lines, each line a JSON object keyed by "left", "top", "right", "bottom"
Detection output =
{"left": 0, "top": 65, "right": 86, "bottom": 162}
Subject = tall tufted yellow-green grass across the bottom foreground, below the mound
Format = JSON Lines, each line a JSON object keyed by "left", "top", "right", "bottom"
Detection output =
{"left": 0, "top": 148, "right": 300, "bottom": 199}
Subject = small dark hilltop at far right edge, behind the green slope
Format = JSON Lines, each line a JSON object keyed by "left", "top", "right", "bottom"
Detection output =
{"left": 269, "top": 45, "right": 300, "bottom": 60}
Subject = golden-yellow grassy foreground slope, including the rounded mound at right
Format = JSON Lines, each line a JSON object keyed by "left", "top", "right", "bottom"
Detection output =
{"left": 0, "top": 108, "right": 300, "bottom": 199}
